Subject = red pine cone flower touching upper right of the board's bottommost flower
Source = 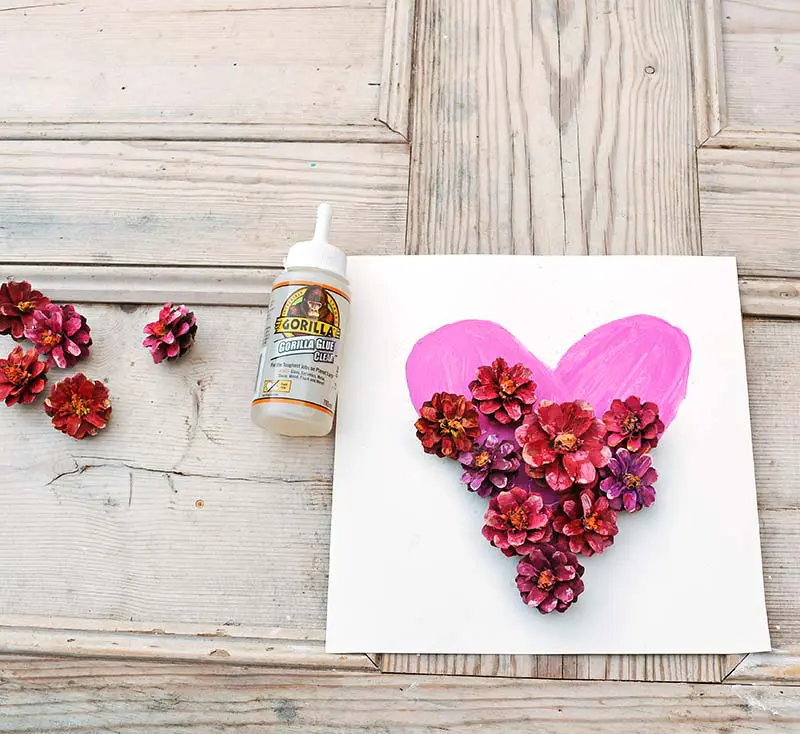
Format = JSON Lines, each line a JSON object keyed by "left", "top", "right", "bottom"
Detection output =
{"left": 553, "top": 489, "right": 618, "bottom": 556}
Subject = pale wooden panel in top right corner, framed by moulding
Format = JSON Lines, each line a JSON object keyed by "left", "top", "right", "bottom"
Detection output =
{"left": 722, "top": 0, "right": 800, "bottom": 132}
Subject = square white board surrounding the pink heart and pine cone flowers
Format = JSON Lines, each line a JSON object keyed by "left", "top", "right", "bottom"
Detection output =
{"left": 326, "top": 256, "right": 770, "bottom": 654}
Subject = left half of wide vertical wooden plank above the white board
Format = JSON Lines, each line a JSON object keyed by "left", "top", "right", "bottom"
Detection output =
{"left": 407, "top": 0, "right": 564, "bottom": 254}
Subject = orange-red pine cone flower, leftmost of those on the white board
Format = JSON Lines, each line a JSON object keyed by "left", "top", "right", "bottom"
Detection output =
{"left": 414, "top": 392, "right": 481, "bottom": 459}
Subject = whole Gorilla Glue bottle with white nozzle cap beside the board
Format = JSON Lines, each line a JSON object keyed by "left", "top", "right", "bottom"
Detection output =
{"left": 251, "top": 204, "right": 350, "bottom": 436}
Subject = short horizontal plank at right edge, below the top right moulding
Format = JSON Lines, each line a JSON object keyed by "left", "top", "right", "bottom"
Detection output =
{"left": 697, "top": 148, "right": 800, "bottom": 277}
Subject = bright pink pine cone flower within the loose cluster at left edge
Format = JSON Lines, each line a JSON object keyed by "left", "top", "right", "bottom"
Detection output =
{"left": 25, "top": 303, "right": 92, "bottom": 369}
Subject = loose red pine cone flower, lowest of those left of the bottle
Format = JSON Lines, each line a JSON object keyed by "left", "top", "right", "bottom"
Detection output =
{"left": 44, "top": 372, "right": 111, "bottom": 439}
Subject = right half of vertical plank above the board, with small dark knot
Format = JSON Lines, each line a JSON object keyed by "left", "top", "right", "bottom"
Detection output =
{"left": 556, "top": 0, "right": 700, "bottom": 255}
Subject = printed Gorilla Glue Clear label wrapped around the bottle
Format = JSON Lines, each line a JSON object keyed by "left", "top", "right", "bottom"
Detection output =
{"left": 253, "top": 280, "right": 350, "bottom": 415}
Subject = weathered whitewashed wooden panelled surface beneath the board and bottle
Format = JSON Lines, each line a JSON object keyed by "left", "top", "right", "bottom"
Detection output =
{"left": 0, "top": 0, "right": 800, "bottom": 733}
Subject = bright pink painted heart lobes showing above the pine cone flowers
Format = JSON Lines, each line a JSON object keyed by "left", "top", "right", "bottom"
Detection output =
{"left": 406, "top": 315, "right": 692, "bottom": 434}
